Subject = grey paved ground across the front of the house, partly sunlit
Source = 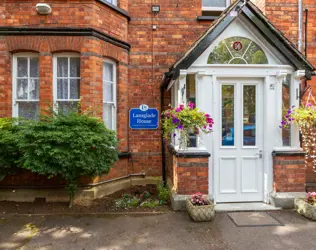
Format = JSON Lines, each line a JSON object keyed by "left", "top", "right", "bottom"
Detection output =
{"left": 0, "top": 211, "right": 316, "bottom": 250}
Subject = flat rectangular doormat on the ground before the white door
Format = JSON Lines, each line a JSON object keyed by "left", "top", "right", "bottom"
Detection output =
{"left": 227, "top": 212, "right": 284, "bottom": 227}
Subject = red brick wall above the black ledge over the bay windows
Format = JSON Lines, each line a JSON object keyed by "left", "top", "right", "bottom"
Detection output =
{"left": 0, "top": 0, "right": 128, "bottom": 40}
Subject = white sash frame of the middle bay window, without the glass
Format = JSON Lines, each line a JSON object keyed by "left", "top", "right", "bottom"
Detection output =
{"left": 53, "top": 53, "right": 81, "bottom": 112}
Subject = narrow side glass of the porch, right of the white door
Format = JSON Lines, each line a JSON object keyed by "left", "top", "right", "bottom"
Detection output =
{"left": 282, "top": 75, "right": 291, "bottom": 146}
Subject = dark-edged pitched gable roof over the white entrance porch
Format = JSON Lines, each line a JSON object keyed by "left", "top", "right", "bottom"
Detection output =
{"left": 162, "top": 0, "right": 315, "bottom": 88}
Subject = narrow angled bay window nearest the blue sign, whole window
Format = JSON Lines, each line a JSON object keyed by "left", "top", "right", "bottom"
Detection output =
{"left": 103, "top": 59, "right": 116, "bottom": 130}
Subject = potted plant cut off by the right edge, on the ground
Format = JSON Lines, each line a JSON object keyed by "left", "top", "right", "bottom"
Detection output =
{"left": 294, "top": 192, "right": 316, "bottom": 220}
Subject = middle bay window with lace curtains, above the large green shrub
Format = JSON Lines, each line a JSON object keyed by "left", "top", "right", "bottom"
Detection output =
{"left": 53, "top": 54, "right": 80, "bottom": 114}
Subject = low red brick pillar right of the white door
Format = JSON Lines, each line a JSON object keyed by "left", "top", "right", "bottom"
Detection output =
{"left": 272, "top": 152, "right": 306, "bottom": 192}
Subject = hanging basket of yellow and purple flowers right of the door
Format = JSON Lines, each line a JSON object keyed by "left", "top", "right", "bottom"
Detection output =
{"left": 280, "top": 102, "right": 316, "bottom": 171}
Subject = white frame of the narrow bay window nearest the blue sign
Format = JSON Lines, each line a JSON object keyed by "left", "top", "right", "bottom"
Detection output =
{"left": 102, "top": 58, "right": 117, "bottom": 131}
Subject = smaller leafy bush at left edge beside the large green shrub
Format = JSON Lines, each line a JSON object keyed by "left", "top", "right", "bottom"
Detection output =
{"left": 0, "top": 118, "right": 21, "bottom": 180}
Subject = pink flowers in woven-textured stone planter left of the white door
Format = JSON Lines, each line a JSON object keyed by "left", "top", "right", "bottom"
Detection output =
{"left": 186, "top": 192, "right": 215, "bottom": 222}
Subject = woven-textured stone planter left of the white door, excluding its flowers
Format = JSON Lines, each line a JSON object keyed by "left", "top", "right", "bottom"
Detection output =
{"left": 186, "top": 199, "right": 215, "bottom": 222}
